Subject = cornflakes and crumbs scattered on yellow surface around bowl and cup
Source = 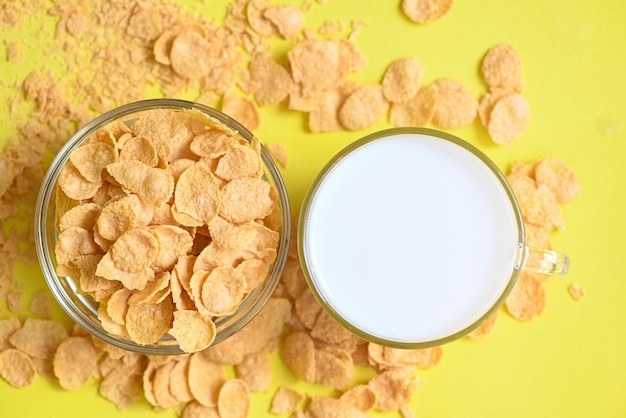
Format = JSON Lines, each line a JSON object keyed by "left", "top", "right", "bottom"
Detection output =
{"left": 0, "top": 0, "right": 584, "bottom": 418}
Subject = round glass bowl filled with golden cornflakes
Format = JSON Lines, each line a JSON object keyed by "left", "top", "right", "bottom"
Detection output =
{"left": 35, "top": 99, "right": 291, "bottom": 355}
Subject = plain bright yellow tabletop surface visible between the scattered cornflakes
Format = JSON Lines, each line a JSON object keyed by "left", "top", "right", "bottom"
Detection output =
{"left": 0, "top": 0, "right": 626, "bottom": 418}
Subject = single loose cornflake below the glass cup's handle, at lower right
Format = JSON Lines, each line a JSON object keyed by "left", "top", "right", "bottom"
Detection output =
{"left": 504, "top": 271, "right": 546, "bottom": 321}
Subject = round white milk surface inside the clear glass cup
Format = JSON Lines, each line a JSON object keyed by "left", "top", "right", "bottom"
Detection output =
{"left": 302, "top": 134, "right": 519, "bottom": 342}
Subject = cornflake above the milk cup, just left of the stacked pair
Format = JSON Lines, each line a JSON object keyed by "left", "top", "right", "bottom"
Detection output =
{"left": 433, "top": 78, "right": 478, "bottom": 129}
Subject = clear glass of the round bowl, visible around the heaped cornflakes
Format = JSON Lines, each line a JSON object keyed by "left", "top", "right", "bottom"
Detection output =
{"left": 35, "top": 99, "right": 291, "bottom": 355}
